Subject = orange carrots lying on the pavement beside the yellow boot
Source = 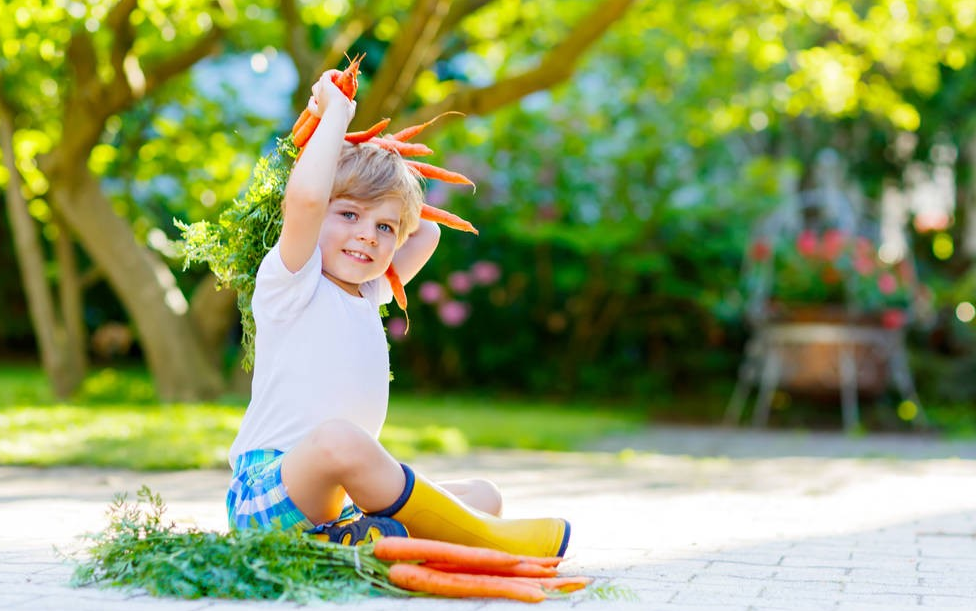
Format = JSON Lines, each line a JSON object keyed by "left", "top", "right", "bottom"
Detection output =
{"left": 364, "top": 537, "right": 592, "bottom": 602}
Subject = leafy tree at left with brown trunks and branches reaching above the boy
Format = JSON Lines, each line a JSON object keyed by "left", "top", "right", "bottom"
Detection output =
{"left": 0, "top": 0, "right": 632, "bottom": 399}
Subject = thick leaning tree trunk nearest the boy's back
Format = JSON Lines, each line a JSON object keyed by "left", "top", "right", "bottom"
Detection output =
{"left": 51, "top": 160, "right": 223, "bottom": 400}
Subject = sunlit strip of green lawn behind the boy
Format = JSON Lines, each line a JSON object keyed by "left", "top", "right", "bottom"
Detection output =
{"left": 0, "top": 366, "right": 642, "bottom": 470}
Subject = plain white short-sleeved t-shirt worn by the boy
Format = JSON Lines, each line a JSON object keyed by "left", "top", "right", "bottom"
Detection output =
{"left": 230, "top": 245, "right": 393, "bottom": 466}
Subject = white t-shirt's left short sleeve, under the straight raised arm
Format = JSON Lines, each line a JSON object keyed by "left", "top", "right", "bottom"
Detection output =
{"left": 252, "top": 244, "right": 322, "bottom": 320}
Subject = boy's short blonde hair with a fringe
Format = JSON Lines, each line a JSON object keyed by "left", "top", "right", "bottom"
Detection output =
{"left": 329, "top": 142, "right": 424, "bottom": 248}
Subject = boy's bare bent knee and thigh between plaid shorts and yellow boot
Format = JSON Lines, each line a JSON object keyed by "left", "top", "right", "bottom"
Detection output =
{"left": 281, "top": 420, "right": 406, "bottom": 524}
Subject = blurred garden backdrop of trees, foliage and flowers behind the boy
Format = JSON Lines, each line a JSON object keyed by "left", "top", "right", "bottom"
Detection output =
{"left": 0, "top": 0, "right": 976, "bottom": 460}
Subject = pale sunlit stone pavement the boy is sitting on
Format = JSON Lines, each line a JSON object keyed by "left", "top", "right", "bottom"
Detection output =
{"left": 0, "top": 427, "right": 976, "bottom": 611}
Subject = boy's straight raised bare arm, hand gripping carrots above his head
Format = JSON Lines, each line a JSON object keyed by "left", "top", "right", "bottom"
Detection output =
{"left": 279, "top": 71, "right": 356, "bottom": 272}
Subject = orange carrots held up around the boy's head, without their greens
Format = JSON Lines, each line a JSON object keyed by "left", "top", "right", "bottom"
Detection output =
{"left": 291, "top": 55, "right": 478, "bottom": 312}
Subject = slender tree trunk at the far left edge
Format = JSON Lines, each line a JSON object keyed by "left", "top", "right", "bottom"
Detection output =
{"left": 0, "top": 106, "right": 85, "bottom": 398}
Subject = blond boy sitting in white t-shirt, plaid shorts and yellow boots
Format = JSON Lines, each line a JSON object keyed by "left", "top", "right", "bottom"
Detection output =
{"left": 227, "top": 73, "right": 569, "bottom": 556}
